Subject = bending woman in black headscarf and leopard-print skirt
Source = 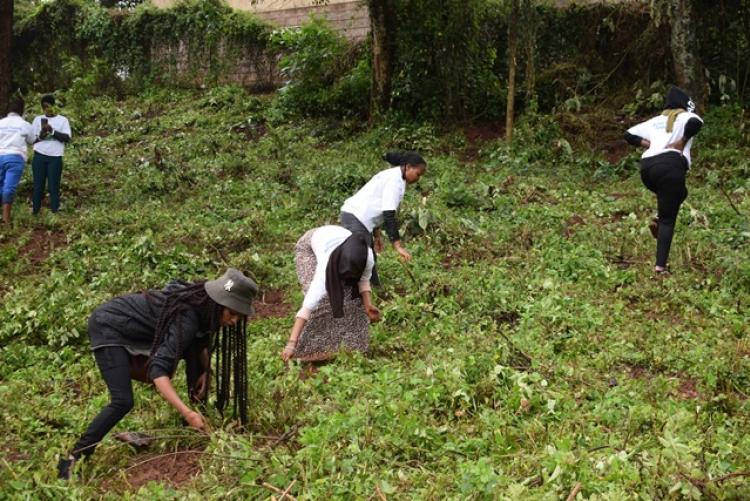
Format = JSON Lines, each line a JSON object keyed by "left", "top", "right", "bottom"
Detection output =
{"left": 281, "top": 225, "right": 380, "bottom": 362}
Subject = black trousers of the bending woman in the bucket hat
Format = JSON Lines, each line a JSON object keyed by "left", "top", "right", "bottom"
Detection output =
{"left": 71, "top": 346, "right": 208, "bottom": 459}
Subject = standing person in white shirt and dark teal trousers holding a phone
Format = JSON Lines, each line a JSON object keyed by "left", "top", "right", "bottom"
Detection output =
{"left": 31, "top": 95, "right": 71, "bottom": 214}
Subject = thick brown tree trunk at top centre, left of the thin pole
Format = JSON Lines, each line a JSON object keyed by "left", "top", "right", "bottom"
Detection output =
{"left": 368, "top": 0, "right": 396, "bottom": 117}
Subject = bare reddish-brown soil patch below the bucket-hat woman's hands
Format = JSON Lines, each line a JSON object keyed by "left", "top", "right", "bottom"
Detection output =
{"left": 102, "top": 450, "right": 202, "bottom": 490}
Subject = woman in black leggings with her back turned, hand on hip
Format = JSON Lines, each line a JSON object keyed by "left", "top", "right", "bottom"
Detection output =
{"left": 625, "top": 86, "right": 703, "bottom": 274}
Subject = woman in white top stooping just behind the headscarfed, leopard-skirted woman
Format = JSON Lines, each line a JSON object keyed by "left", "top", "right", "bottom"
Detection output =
{"left": 341, "top": 151, "right": 427, "bottom": 285}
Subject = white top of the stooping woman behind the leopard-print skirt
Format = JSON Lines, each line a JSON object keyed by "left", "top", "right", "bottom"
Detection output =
{"left": 341, "top": 167, "right": 406, "bottom": 231}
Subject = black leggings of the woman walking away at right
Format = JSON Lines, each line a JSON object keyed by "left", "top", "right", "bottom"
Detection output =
{"left": 641, "top": 152, "right": 687, "bottom": 267}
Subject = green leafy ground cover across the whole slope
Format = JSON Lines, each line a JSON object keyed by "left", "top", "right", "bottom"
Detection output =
{"left": 0, "top": 87, "right": 750, "bottom": 499}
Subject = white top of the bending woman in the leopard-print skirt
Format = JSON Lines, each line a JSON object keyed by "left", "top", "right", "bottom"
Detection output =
{"left": 297, "top": 225, "right": 375, "bottom": 320}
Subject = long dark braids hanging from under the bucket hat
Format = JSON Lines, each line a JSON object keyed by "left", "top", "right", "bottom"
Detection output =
{"left": 144, "top": 281, "right": 247, "bottom": 426}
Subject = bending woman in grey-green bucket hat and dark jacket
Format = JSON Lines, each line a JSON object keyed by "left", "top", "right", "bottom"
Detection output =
{"left": 58, "top": 268, "right": 258, "bottom": 479}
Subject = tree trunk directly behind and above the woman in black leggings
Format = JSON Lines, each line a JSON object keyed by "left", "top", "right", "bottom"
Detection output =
{"left": 670, "top": 0, "right": 706, "bottom": 105}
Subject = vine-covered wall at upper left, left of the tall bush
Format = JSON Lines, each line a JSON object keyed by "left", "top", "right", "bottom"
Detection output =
{"left": 13, "top": 0, "right": 278, "bottom": 94}
